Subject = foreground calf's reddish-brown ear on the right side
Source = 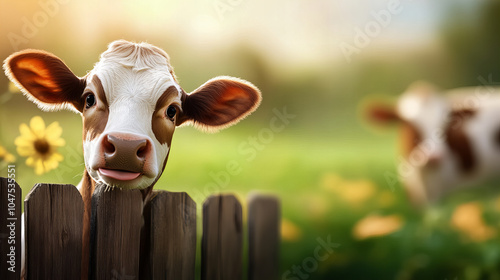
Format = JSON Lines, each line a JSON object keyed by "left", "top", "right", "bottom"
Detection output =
{"left": 176, "top": 76, "right": 262, "bottom": 131}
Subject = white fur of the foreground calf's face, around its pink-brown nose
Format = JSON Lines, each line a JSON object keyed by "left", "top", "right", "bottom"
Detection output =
{"left": 83, "top": 41, "right": 182, "bottom": 188}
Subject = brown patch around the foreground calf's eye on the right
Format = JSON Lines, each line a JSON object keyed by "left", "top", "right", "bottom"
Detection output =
{"left": 151, "top": 86, "right": 180, "bottom": 147}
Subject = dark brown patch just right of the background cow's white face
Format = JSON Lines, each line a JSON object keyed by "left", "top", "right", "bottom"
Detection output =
{"left": 445, "top": 109, "right": 476, "bottom": 172}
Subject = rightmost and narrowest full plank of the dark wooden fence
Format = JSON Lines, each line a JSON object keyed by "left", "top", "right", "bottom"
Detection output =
{"left": 248, "top": 195, "right": 281, "bottom": 280}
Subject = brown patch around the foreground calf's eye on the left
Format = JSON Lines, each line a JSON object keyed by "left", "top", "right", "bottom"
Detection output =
{"left": 82, "top": 75, "right": 109, "bottom": 141}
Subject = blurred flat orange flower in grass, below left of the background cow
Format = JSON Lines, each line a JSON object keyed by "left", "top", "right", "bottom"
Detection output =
{"left": 352, "top": 215, "right": 403, "bottom": 239}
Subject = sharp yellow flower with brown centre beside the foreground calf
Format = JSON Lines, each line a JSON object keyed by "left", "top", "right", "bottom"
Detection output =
{"left": 14, "top": 116, "right": 66, "bottom": 175}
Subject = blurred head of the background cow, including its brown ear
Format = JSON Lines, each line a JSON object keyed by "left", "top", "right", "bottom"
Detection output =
{"left": 368, "top": 82, "right": 474, "bottom": 205}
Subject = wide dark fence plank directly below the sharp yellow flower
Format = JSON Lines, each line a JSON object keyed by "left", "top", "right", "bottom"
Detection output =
{"left": 24, "top": 184, "right": 83, "bottom": 279}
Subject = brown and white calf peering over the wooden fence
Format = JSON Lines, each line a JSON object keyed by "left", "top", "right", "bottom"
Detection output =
{"left": 4, "top": 40, "right": 261, "bottom": 278}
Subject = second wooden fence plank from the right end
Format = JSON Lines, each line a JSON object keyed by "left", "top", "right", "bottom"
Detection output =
{"left": 201, "top": 195, "right": 243, "bottom": 280}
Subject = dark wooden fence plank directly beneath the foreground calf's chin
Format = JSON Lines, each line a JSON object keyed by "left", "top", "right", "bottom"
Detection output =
{"left": 89, "top": 186, "right": 143, "bottom": 280}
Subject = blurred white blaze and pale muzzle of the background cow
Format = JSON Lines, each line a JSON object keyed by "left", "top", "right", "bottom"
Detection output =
{"left": 396, "top": 84, "right": 454, "bottom": 205}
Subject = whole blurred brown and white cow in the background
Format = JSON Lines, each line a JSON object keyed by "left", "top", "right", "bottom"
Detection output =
{"left": 369, "top": 82, "right": 500, "bottom": 205}
